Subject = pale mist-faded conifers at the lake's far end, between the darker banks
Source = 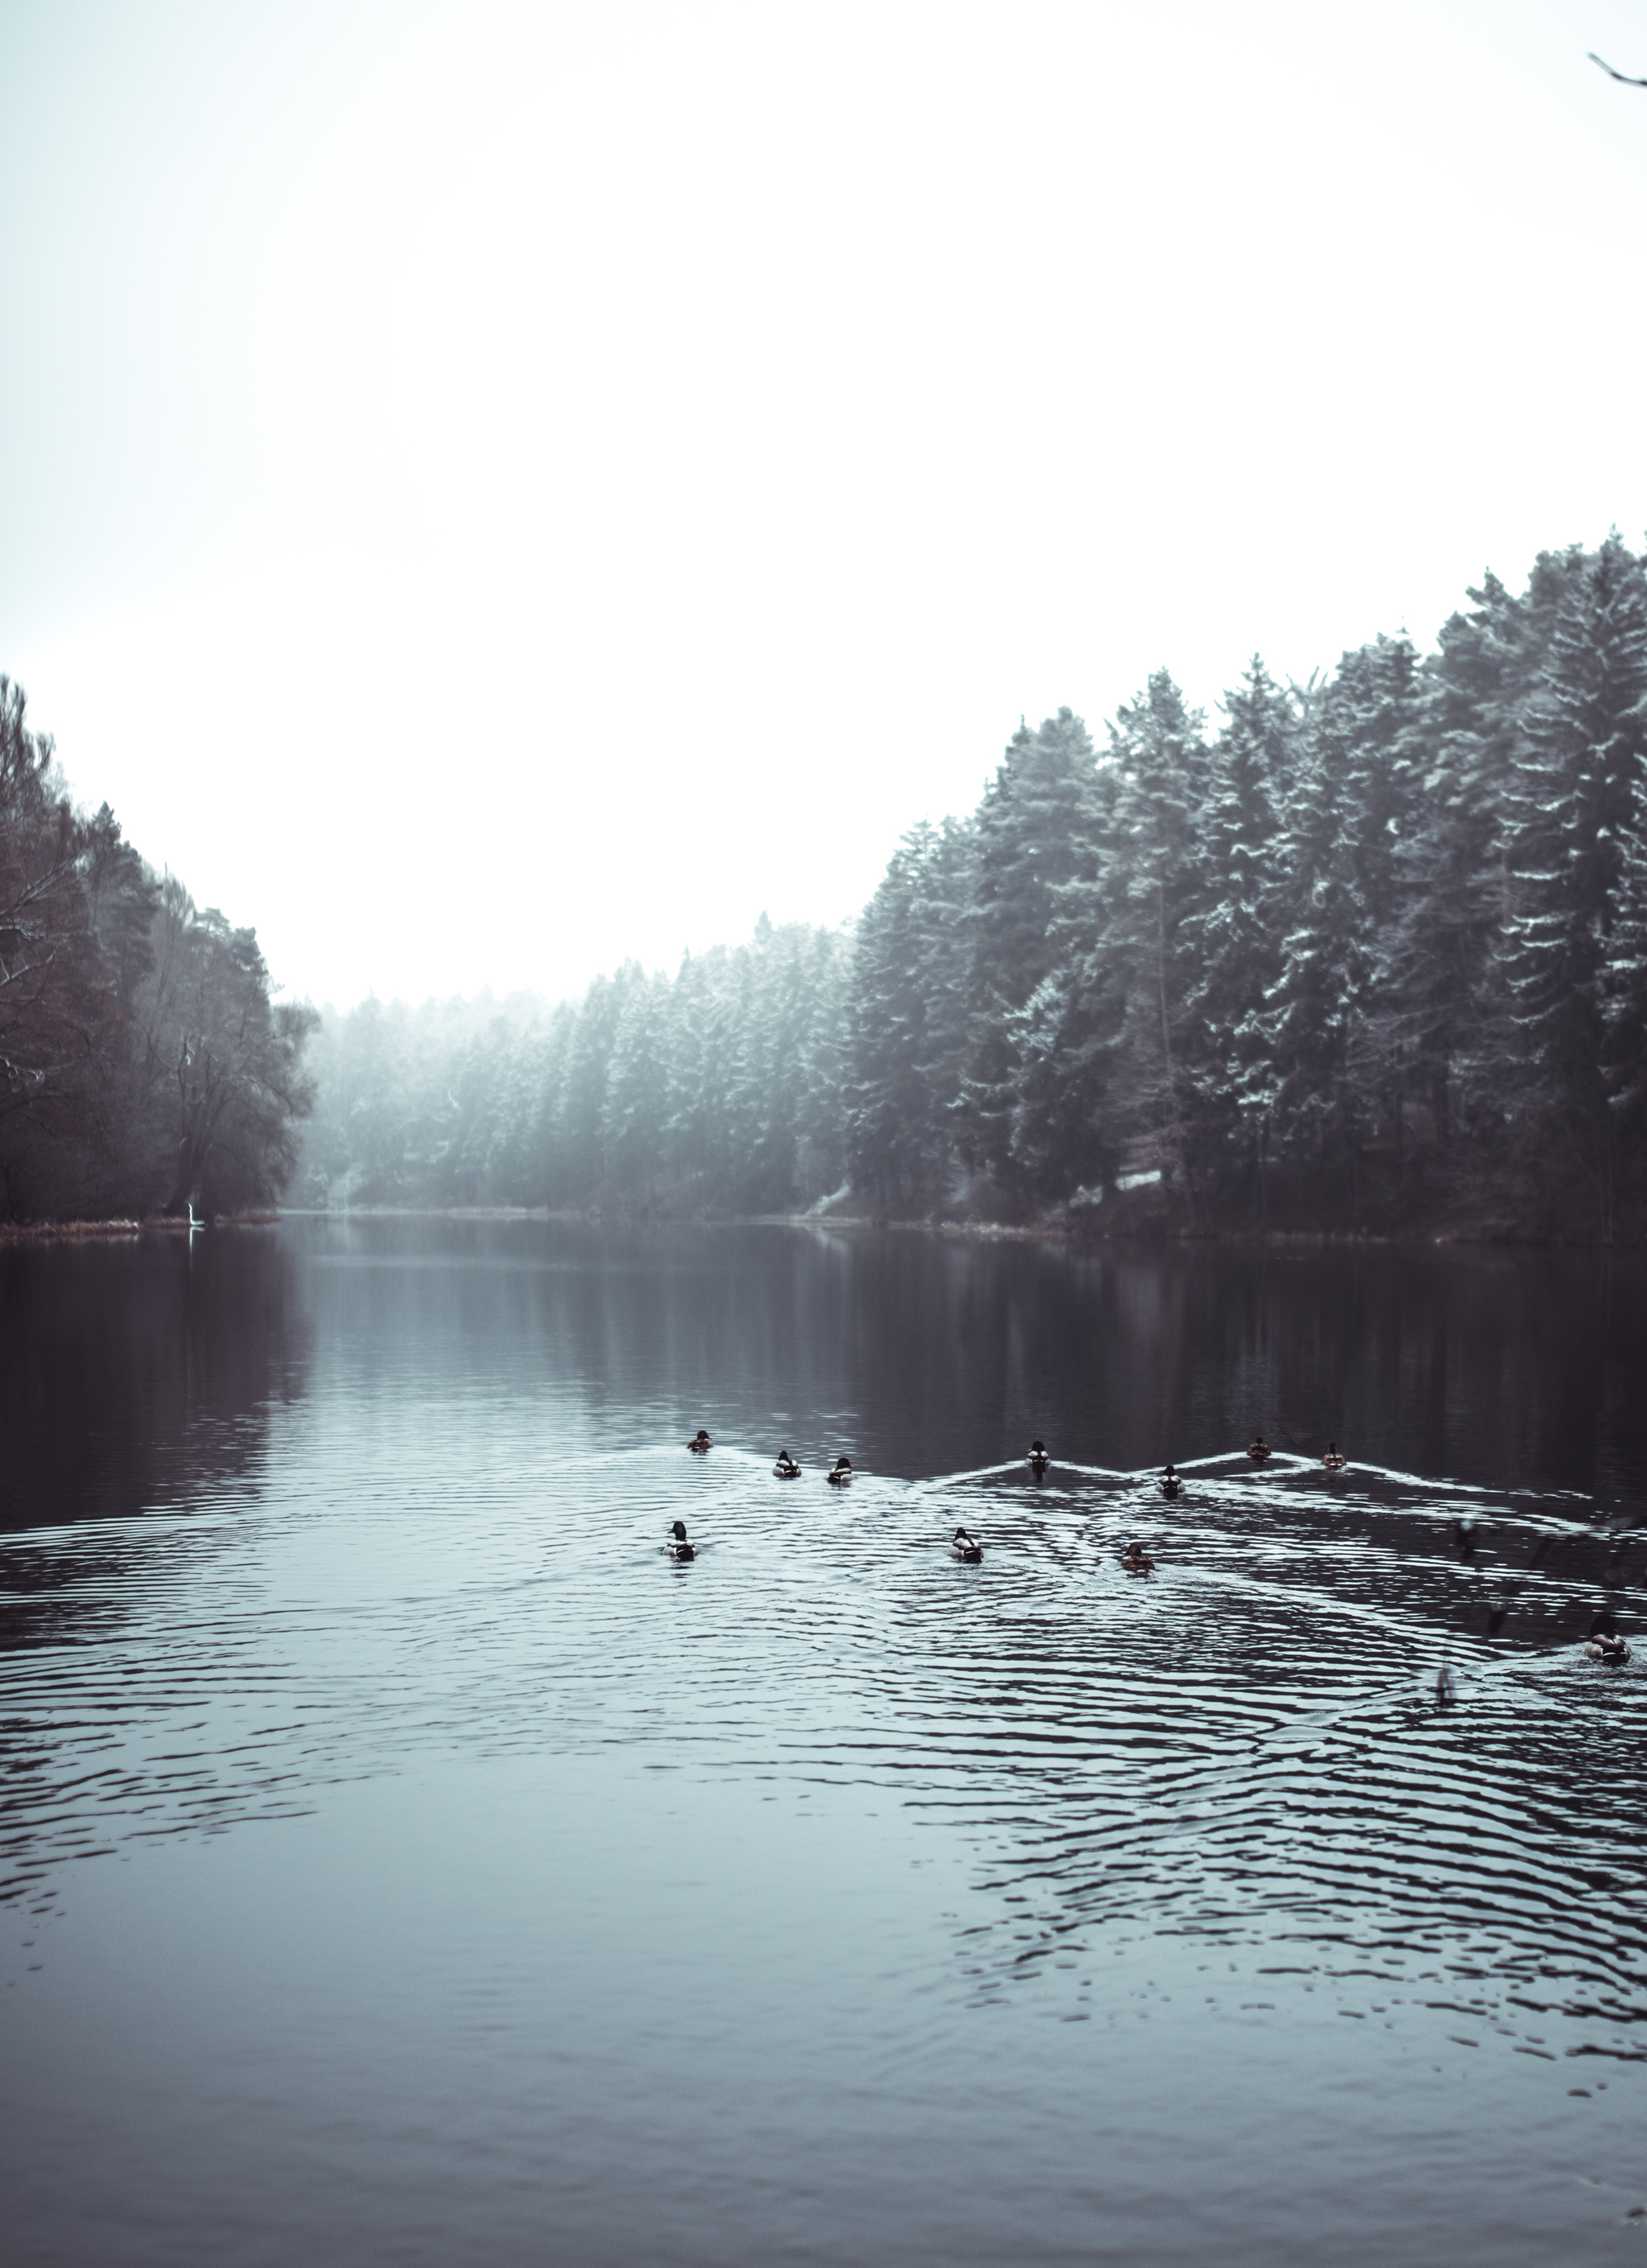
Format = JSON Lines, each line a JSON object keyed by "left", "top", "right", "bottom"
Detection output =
{"left": 295, "top": 918, "right": 851, "bottom": 1214}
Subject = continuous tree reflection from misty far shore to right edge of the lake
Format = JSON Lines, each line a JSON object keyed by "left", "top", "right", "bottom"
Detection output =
{"left": 342, "top": 1220, "right": 1647, "bottom": 1497}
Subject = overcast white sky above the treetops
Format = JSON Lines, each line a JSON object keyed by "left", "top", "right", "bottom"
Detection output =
{"left": 0, "top": 0, "right": 1647, "bottom": 1005}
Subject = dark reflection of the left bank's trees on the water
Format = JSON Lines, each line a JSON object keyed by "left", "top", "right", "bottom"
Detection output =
{"left": 0, "top": 1229, "right": 306, "bottom": 1551}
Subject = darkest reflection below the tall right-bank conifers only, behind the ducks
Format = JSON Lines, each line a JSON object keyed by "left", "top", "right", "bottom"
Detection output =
{"left": 830, "top": 1234, "right": 1647, "bottom": 1493}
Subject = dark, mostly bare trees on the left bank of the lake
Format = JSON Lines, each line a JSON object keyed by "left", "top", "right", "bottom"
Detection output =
{"left": 0, "top": 676, "right": 313, "bottom": 1220}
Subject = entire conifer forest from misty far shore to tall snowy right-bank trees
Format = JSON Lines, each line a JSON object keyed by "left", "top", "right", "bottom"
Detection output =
{"left": 306, "top": 537, "right": 1647, "bottom": 1239}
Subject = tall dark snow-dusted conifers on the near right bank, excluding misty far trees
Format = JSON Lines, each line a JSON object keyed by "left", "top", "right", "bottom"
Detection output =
{"left": 848, "top": 537, "right": 1647, "bottom": 1239}
